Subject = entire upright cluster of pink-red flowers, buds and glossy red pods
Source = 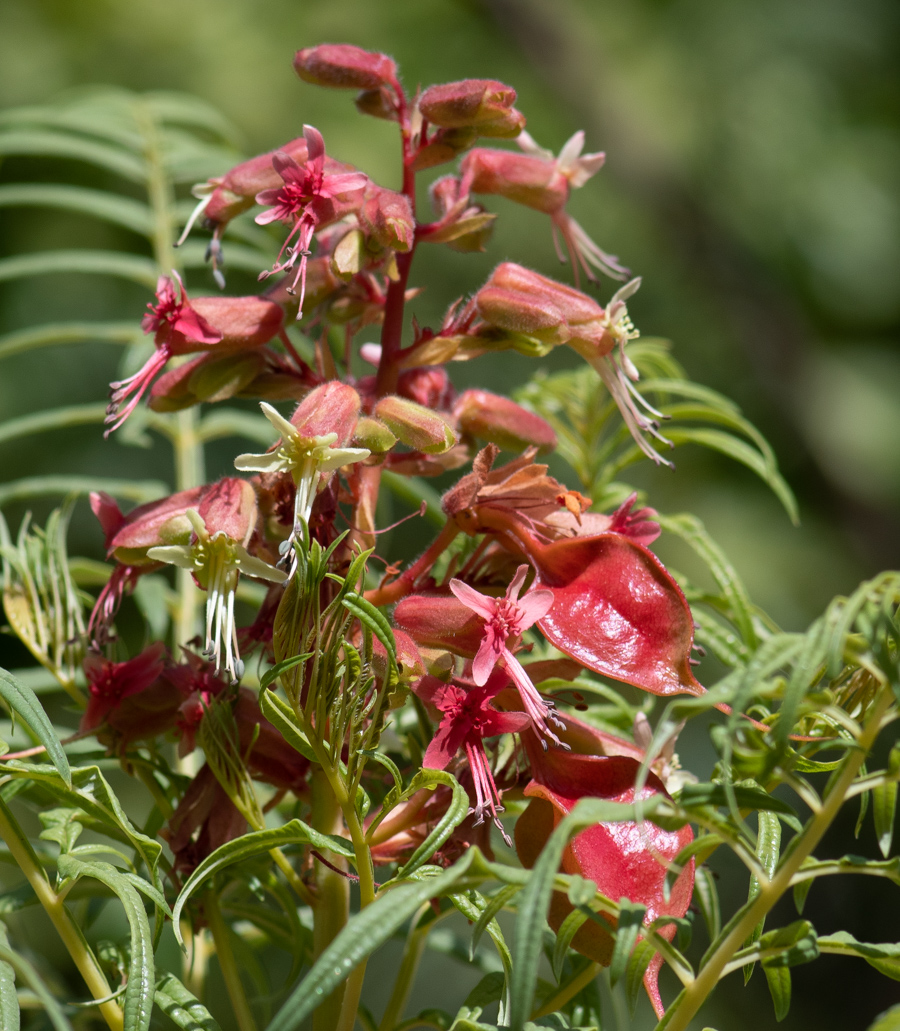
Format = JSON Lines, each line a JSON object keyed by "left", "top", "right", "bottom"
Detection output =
{"left": 81, "top": 45, "right": 704, "bottom": 1009}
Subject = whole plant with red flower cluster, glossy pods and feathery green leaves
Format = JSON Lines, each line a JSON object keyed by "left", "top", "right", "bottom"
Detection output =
{"left": 0, "top": 45, "right": 900, "bottom": 1031}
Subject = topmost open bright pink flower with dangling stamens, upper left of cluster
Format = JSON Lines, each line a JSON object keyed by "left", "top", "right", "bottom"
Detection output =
{"left": 256, "top": 126, "right": 368, "bottom": 319}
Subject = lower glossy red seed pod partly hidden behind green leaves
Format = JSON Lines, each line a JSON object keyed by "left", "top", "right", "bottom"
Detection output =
{"left": 515, "top": 735, "right": 694, "bottom": 1017}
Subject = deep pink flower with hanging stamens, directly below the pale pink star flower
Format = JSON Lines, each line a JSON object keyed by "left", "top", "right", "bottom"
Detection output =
{"left": 415, "top": 672, "right": 531, "bottom": 845}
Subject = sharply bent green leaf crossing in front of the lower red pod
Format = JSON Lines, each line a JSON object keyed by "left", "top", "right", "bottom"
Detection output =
{"left": 509, "top": 796, "right": 663, "bottom": 1031}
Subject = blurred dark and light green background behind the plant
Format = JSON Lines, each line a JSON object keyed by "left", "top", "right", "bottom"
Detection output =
{"left": 0, "top": 0, "right": 900, "bottom": 1031}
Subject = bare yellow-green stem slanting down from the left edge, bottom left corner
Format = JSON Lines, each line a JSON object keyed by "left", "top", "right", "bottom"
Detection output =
{"left": 0, "top": 799, "right": 124, "bottom": 1031}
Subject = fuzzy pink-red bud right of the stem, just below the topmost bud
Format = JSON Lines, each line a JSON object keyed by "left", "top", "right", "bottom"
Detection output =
{"left": 419, "top": 78, "right": 525, "bottom": 137}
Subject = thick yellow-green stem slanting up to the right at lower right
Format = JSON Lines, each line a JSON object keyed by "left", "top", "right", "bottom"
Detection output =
{"left": 665, "top": 685, "right": 894, "bottom": 1031}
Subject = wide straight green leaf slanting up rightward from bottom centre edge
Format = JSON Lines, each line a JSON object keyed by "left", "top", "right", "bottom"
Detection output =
{"left": 266, "top": 849, "right": 480, "bottom": 1031}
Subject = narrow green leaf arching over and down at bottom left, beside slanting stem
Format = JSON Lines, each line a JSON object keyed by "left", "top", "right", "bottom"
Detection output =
{"left": 58, "top": 856, "right": 156, "bottom": 1031}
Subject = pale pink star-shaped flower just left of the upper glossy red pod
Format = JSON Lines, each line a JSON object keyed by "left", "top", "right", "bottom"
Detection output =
{"left": 449, "top": 565, "right": 559, "bottom": 743}
